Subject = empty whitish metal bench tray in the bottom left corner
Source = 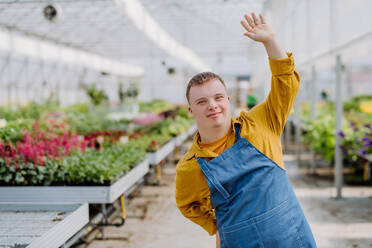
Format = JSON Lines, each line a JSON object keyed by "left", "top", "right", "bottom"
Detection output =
{"left": 0, "top": 204, "right": 89, "bottom": 248}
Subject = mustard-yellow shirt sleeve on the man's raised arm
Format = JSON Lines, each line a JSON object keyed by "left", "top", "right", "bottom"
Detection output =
{"left": 263, "top": 53, "right": 300, "bottom": 136}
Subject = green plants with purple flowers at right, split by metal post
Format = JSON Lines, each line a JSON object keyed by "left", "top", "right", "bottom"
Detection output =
{"left": 301, "top": 95, "right": 372, "bottom": 184}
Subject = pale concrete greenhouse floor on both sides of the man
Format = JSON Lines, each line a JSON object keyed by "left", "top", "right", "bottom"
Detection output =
{"left": 78, "top": 148, "right": 372, "bottom": 248}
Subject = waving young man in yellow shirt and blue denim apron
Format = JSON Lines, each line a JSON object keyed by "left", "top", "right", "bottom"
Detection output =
{"left": 176, "top": 13, "right": 316, "bottom": 248}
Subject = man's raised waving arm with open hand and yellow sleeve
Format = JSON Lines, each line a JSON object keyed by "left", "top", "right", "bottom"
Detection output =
{"left": 241, "top": 14, "right": 300, "bottom": 136}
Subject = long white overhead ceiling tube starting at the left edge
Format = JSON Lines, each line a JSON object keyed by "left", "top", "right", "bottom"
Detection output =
{"left": 0, "top": 27, "right": 144, "bottom": 77}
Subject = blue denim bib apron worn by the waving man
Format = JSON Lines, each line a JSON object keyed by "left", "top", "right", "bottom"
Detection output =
{"left": 197, "top": 124, "right": 316, "bottom": 248}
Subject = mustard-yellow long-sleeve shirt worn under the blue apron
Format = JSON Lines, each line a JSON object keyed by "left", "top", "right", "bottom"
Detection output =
{"left": 175, "top": 53, "right": 300, "bottom": 235}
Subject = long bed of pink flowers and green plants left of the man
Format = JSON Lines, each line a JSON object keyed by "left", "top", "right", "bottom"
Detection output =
{"left": 0, "top": 100, "right": 192, "bottom": 186}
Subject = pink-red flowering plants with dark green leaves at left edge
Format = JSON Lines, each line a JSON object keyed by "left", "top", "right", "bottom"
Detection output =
{"left": 0, "top": 121, "right": 88, "bottom": 185}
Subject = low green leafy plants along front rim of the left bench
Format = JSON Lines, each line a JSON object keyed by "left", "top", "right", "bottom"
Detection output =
{"left": 0, "top": 140, "right": 146, "bottom": 186}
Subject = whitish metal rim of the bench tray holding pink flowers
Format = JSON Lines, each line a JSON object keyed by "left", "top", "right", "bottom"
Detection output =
{"left": 0, "top": 160, "right": 149, "bottom": 203}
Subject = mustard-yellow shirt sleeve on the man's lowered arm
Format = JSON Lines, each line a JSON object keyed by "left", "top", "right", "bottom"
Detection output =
{"left": 175, "top": 162, "right": 217, "bottom": 236}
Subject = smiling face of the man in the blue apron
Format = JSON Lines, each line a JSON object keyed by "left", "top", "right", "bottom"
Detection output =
{"left": 189, "top": 79, "right": 231, "bottom": 128}
